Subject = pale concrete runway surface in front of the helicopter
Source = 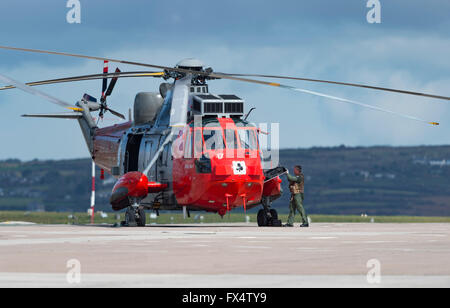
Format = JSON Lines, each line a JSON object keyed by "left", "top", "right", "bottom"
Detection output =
{"left": 0, "top": 224, "right": 450, "bottom": 288}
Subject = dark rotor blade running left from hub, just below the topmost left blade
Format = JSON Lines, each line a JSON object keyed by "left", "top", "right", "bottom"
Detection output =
{"left": 0, "top": 71, "right": 164, "bottom": 91}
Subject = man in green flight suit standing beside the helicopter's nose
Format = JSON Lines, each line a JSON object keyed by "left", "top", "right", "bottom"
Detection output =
{"left": 284, "top": 166, "right": 309, "bottom": 227}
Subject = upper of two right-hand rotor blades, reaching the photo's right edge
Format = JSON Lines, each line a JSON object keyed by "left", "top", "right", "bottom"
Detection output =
{"left": 224, "top": 74, "right": 450, "bottom": 100}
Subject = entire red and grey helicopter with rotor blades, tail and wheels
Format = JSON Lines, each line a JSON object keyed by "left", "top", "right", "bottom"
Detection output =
{"left": 0, "top": 46, "right": 450, "bottom": 227}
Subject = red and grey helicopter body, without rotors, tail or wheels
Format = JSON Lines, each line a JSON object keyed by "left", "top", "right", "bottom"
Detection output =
{"left": 93, "top": 88, "right": 281, "bottom": 215}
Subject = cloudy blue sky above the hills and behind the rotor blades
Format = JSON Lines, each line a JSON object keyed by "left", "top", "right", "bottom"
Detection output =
{"left": 0, "top": 0, "right": 450, "bottom": 160}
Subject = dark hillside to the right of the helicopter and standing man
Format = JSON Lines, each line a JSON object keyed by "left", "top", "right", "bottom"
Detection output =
{"left": 280, "top": 146, "right": 450, "bottom": 216}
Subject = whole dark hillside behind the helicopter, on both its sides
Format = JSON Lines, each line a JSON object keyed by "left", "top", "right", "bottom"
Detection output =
{"left": 0, "top": 146, "right": 450, "bottom": 216}
